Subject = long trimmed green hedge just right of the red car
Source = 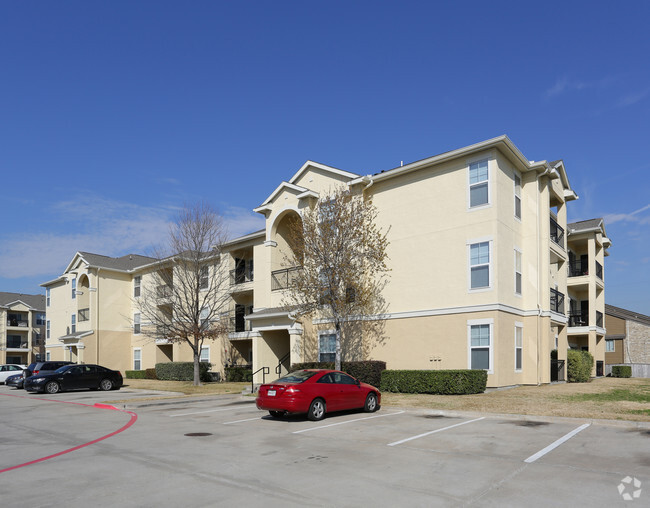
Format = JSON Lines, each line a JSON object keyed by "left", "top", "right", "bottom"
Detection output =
{"left": 381, "top": 370, "right": 487, "bottom": 395}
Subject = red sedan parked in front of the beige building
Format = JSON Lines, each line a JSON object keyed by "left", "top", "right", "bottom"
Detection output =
{"left": 255, "top": 369, "right": 381, "bottom": 421}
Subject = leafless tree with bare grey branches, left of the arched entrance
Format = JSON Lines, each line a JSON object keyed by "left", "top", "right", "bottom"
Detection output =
{"left": 136, "top": 203, "right": 229, "bottom": 385}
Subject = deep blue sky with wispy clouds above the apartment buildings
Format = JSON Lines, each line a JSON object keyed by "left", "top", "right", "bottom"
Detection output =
{"left": 0, "top": 0, "right": 650, "bottom": 314}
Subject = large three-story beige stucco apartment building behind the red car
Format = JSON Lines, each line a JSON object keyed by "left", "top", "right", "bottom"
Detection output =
{"left": 43, "top": 136, "right": 609, "bottom": 387}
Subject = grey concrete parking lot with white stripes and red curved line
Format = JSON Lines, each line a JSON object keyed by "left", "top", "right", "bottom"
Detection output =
{"left": 0, "top": 386, "right": 650, "bottom": 507}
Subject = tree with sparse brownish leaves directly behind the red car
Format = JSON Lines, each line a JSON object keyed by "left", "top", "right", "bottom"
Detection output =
{"left": 285, "top": 188, "right": 389, "bottom": 370}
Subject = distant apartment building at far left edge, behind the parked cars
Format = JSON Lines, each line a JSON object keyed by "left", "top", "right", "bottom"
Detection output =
{"left": 0, "top": 292, "right": 45, "bottom": 365}
